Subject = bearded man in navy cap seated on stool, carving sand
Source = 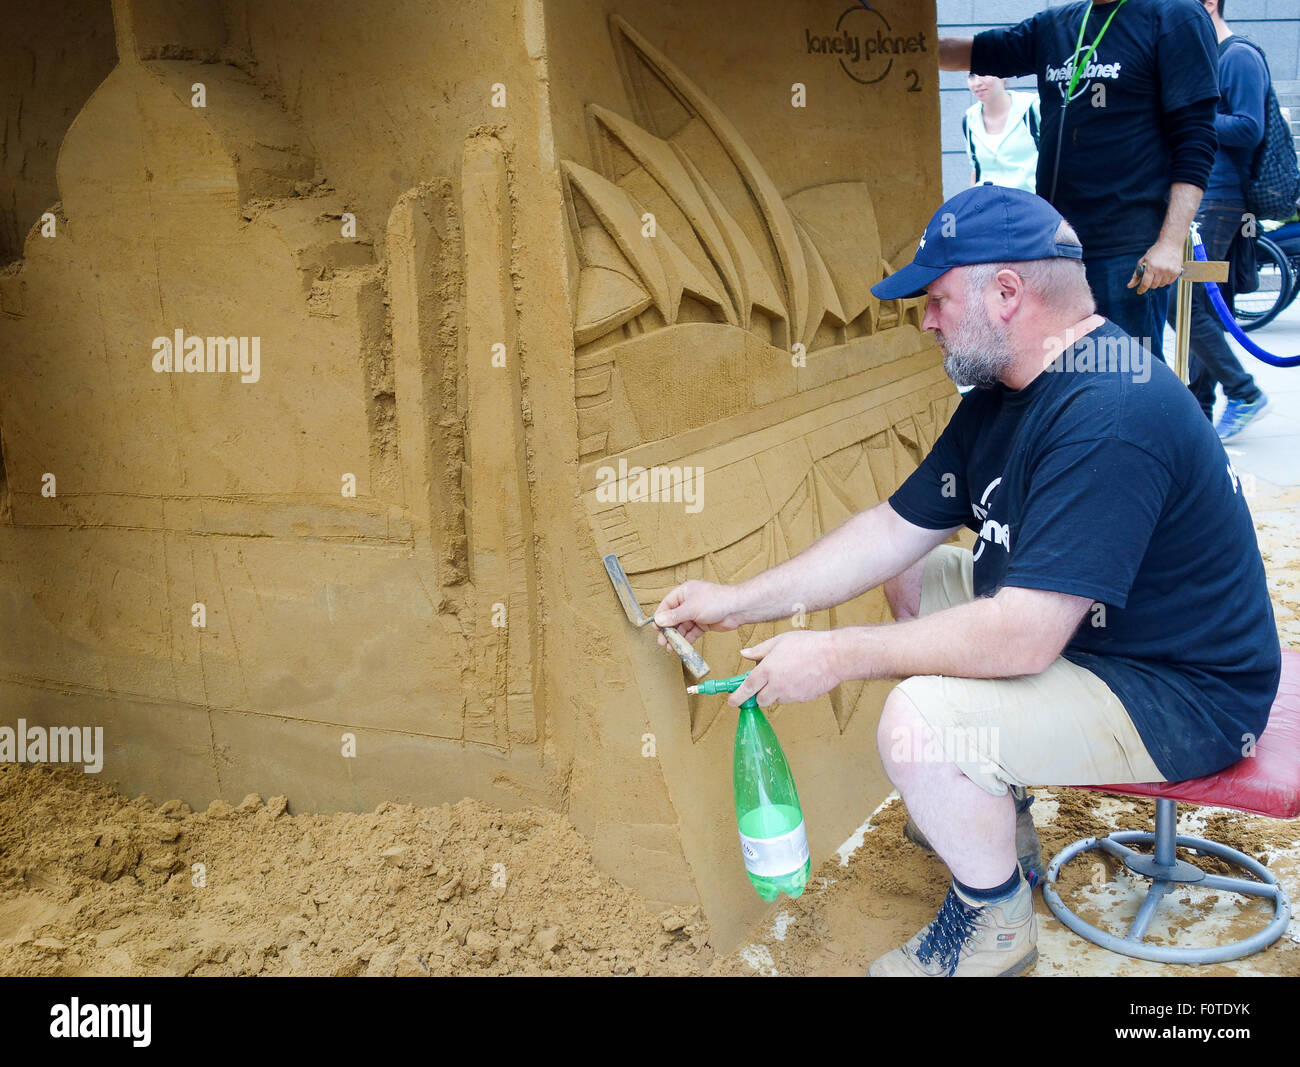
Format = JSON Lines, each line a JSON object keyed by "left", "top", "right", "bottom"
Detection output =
{"left": 655, "top": 186, "right": 1282, "bottom": 976}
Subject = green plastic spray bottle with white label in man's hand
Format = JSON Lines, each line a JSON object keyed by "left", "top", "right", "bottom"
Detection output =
{"left": 686, "top": 672, "right": 811, "bottom": 901}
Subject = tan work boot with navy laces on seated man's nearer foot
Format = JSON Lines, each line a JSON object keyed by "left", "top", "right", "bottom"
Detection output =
{"left": 867, "top": 875, "right": 1039, "bottom": 979}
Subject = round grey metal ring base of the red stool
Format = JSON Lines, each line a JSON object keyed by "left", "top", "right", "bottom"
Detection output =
{"left": 1043, "top": 798, "right": 1291, "bottom": 963}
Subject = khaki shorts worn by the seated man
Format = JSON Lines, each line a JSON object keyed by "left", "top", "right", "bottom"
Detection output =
{"left": 889, "top": 545, "right": 1165, "bottom": 797}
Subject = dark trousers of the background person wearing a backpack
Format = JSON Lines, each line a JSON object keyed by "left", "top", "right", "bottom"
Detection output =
{"left": 1169, "top": 203, "right": 1261, "bottom": 418}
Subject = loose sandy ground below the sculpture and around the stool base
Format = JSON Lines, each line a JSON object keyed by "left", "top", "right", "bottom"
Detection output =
{"left": 0, "top": 483, "right": 1300, "bottom": 976}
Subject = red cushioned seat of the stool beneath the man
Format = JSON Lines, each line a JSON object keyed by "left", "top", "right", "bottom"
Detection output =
{"left": 1076, "top": 651, "right": 1300, "bottom": 819}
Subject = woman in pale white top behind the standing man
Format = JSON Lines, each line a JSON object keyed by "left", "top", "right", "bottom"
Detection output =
{"left": 962, "top": 74, "right": 1040, "bottom": 192}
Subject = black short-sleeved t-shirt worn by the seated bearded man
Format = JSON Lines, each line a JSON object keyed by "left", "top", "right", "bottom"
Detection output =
{"left": 889, "top": 321, "right": 1282, "bottom": 785}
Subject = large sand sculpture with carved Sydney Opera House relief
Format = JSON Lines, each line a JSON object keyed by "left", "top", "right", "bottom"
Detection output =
{"left": 0, "top": 0, "right": 956, "bottom": 941}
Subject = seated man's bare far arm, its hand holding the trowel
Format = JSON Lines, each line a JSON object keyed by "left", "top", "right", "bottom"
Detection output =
{"left": 655, "top": 500, "right": 961, "bottom": 642}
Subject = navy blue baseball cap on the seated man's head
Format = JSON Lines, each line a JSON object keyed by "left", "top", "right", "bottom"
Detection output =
{"left": 871, "top": 182, "right": 1083, "bottom": 300}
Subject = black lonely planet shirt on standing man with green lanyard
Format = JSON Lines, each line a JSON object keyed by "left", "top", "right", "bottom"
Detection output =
{"left": 971, "top": 0, "right": 1218, "bottom": 259}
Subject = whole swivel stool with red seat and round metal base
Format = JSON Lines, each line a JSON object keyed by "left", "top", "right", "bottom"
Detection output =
{"left": 1043, "top": 651, "right": 1300, "bottom": 963}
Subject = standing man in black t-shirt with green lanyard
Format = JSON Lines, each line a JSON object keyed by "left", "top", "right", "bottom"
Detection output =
{"left": 939, "top": 0, "right": 1218, "bottom": 359}
